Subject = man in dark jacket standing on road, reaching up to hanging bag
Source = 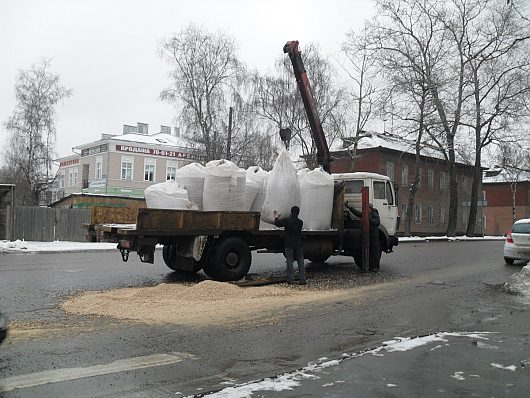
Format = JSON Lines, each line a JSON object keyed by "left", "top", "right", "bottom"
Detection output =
{"left": 273, "top": 206, "right": 306, "bottom": 285}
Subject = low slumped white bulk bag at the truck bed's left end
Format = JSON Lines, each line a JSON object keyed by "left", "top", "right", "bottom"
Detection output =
{"left": 144, "top": 180, "right": 191, "bottom": 210}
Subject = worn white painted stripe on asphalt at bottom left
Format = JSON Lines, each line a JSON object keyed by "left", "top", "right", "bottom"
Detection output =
{"left": 0, "top": 352, "right": 196, "bottom": 393}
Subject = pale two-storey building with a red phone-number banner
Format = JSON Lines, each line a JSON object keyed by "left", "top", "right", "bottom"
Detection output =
{"left": 54, "top": 123, "right": 201, "bottom": 200}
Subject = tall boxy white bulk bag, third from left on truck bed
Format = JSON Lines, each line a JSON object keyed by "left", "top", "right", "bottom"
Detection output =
{"left": 202, "top": 159, "right": 246, "bottom": 211}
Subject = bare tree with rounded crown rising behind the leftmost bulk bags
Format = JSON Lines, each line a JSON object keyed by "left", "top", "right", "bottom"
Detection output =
{"left": 161, "top": 25, "right": 245, "bottom": 160}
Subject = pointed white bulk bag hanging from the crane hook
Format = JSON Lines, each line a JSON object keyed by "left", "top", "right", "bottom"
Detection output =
{"left": 261, "top": 149, "right": 300, "bottom": 224}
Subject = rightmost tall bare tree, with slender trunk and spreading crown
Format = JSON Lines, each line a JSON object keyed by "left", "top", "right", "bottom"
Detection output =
{"left": 457, "top": 0, "right": 530, "bottom": 236}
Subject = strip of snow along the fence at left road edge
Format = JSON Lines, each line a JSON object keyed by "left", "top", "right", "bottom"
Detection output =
{"left": 0, "top": 240, "right": 116, "bottom": 253}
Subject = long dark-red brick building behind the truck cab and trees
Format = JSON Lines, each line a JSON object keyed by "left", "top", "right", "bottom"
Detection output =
{"left": 331, "top": 133, "right": 483, "bottom": 236}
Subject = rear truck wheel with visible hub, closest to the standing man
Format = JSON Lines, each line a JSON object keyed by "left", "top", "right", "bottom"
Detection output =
{"left": 204, "top": 237, "right": 252, "bottom": 282}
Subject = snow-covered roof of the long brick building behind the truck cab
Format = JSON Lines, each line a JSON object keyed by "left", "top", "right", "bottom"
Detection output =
{"left": 330, "top": 132, "right": 469, "bottom": 165}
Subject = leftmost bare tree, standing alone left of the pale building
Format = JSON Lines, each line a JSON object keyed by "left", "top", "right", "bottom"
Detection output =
{"left": 5, "top": 60, "right": 72, "bottom": 205}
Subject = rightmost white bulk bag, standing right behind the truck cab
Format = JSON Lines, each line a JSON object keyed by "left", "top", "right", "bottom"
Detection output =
{"left": 299, "top": 169, "right": 334, "bottom": 230}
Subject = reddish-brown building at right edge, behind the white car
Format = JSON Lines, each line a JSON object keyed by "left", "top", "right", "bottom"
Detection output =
{"left": 482, "top": 167, "right": 530, "bottom": 235}
